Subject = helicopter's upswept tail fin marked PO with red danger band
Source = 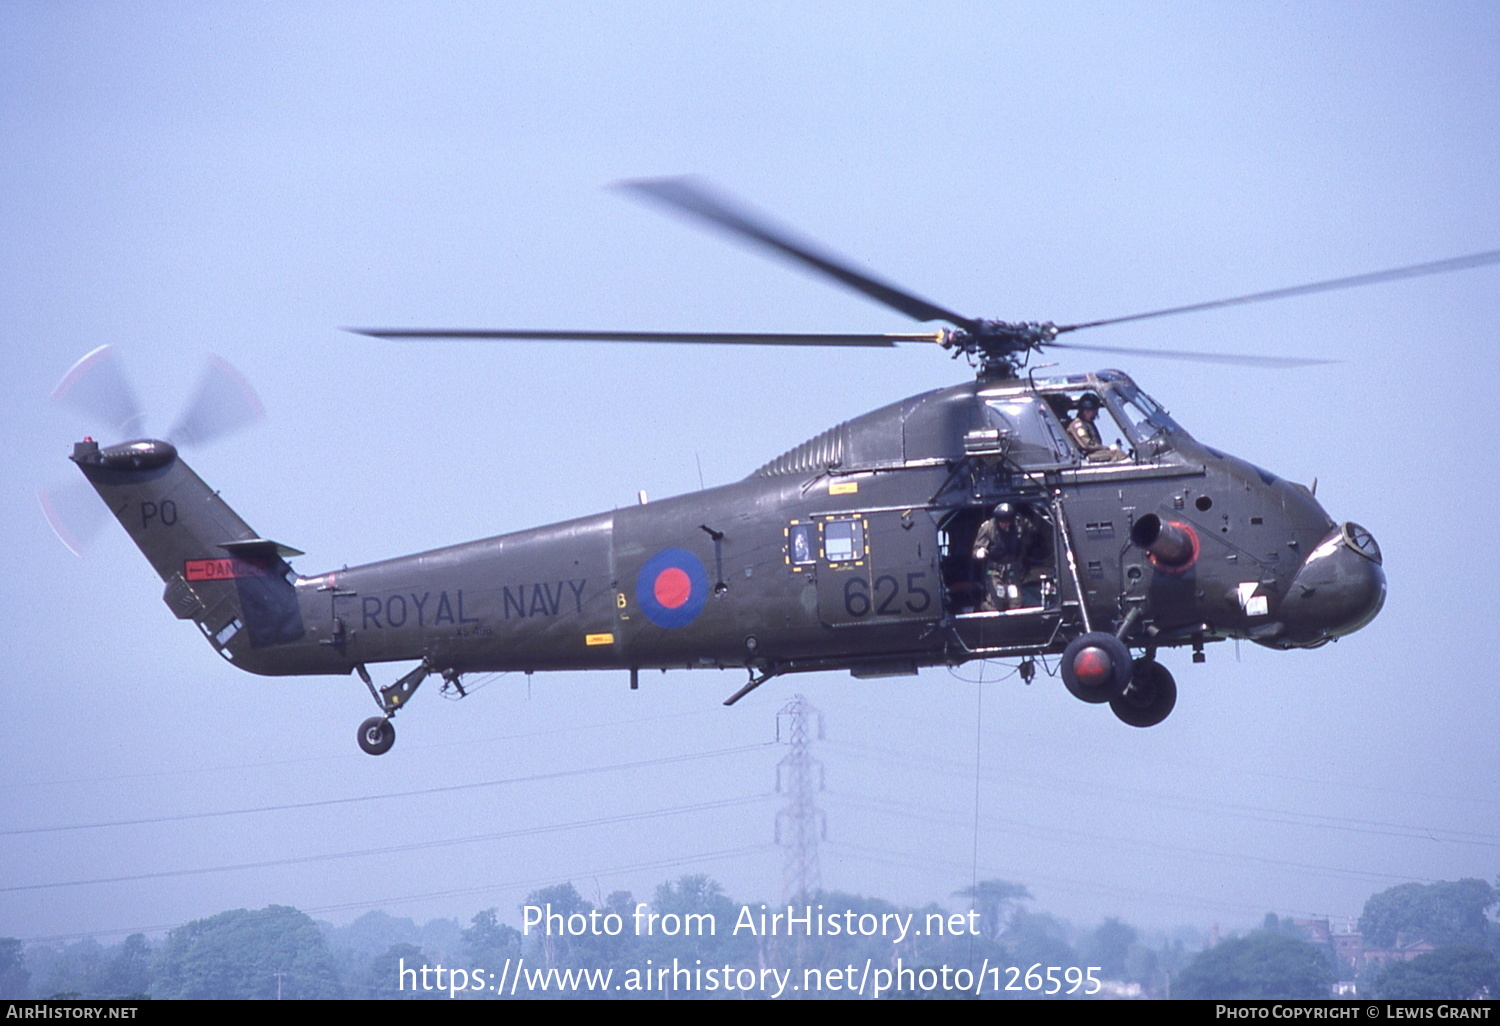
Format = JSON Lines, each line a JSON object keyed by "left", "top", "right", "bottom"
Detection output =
{"left": 72, "top": 440, "right": 306, "bottom": 669}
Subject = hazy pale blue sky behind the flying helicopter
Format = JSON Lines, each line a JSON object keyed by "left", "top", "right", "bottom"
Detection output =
{"left": 0, "top": 0, "right": 1500, "bottom": 941}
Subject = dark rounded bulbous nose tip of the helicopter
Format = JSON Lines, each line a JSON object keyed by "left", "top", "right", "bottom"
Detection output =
{"left": 1278, "top": 524, "right": 1386, "bottom": 648}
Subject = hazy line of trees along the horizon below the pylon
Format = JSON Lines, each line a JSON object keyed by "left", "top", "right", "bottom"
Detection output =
{"left": 0, "top": 875, "right": 1500, "bottom": 1001}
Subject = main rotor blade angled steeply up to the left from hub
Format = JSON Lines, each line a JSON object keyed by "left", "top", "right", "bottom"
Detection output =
{"left": 617, "top": 177, "right": 980, "bottom": 332}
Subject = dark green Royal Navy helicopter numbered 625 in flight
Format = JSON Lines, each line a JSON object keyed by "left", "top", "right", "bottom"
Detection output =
{"left": 52, "top": 179, "right": 1500, "bottom": 755}
